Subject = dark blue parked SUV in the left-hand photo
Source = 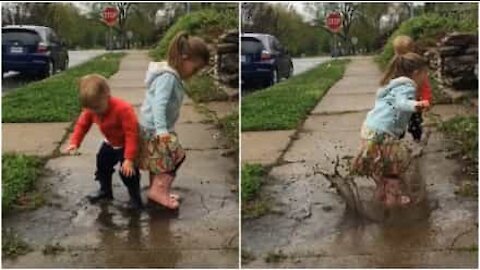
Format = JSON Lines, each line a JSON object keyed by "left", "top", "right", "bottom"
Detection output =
{"left": 2, "top": 25, "right": 68, "bottom": 77}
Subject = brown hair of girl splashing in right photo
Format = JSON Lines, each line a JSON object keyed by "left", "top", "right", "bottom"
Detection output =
{"left": 380, "top": 52, "right": 427, "bottom": 85}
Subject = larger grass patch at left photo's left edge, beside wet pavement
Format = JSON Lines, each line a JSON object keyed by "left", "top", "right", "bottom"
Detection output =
{"left": 2, "top": 154, "right": 43, "bottom": 211}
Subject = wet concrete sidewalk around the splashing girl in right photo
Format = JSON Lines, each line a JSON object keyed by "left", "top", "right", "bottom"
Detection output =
{"left": 242, "top": 58, "right": 478, "bottom": 268}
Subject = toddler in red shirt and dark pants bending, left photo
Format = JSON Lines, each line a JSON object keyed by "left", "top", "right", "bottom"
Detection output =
{"left": 66, "top": 74, "right": 143, "bottom": 209}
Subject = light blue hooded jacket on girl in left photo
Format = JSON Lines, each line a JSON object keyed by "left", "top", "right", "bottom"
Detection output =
{"left": 139, "top": 62, "right": 185, "bottom": 135}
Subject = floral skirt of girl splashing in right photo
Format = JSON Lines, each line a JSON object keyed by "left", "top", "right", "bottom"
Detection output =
{"left": 352, "top": 125, "right": 411, "bottom": 179}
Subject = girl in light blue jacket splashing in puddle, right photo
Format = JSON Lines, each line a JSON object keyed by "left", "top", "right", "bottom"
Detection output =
{"left": 353, "top": 53, "right": 429, "bottom": 207}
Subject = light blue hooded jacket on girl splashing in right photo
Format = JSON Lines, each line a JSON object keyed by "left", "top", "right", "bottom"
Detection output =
{"left": 365, "top": 77, "right": 417, "bottom": 138}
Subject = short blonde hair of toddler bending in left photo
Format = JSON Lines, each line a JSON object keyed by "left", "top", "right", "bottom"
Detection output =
{"left": 79, "top": 74, "right": 110, "bottom": 107}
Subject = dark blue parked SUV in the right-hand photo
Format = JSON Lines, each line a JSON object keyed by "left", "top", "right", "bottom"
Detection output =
{"left": 241, "top": 33, "right": 293, "bottom": 87}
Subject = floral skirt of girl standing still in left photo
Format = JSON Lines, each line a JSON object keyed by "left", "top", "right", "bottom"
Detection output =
{"left": 138, "top": 128, "right": 186, "bottom": 174}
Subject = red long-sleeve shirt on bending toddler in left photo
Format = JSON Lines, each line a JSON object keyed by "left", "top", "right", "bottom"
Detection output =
{"left": 70, "top": 97, "right": 138, "bottom": 160}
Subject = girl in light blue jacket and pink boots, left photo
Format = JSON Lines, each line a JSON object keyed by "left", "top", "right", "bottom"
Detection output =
{"left": 139, "top": 32, "right": 210, "bottom": 209}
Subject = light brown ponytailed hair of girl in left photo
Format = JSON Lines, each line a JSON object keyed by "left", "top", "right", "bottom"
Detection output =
{"left": 167, "top": 32, "right": 210, "bottom": 71}
